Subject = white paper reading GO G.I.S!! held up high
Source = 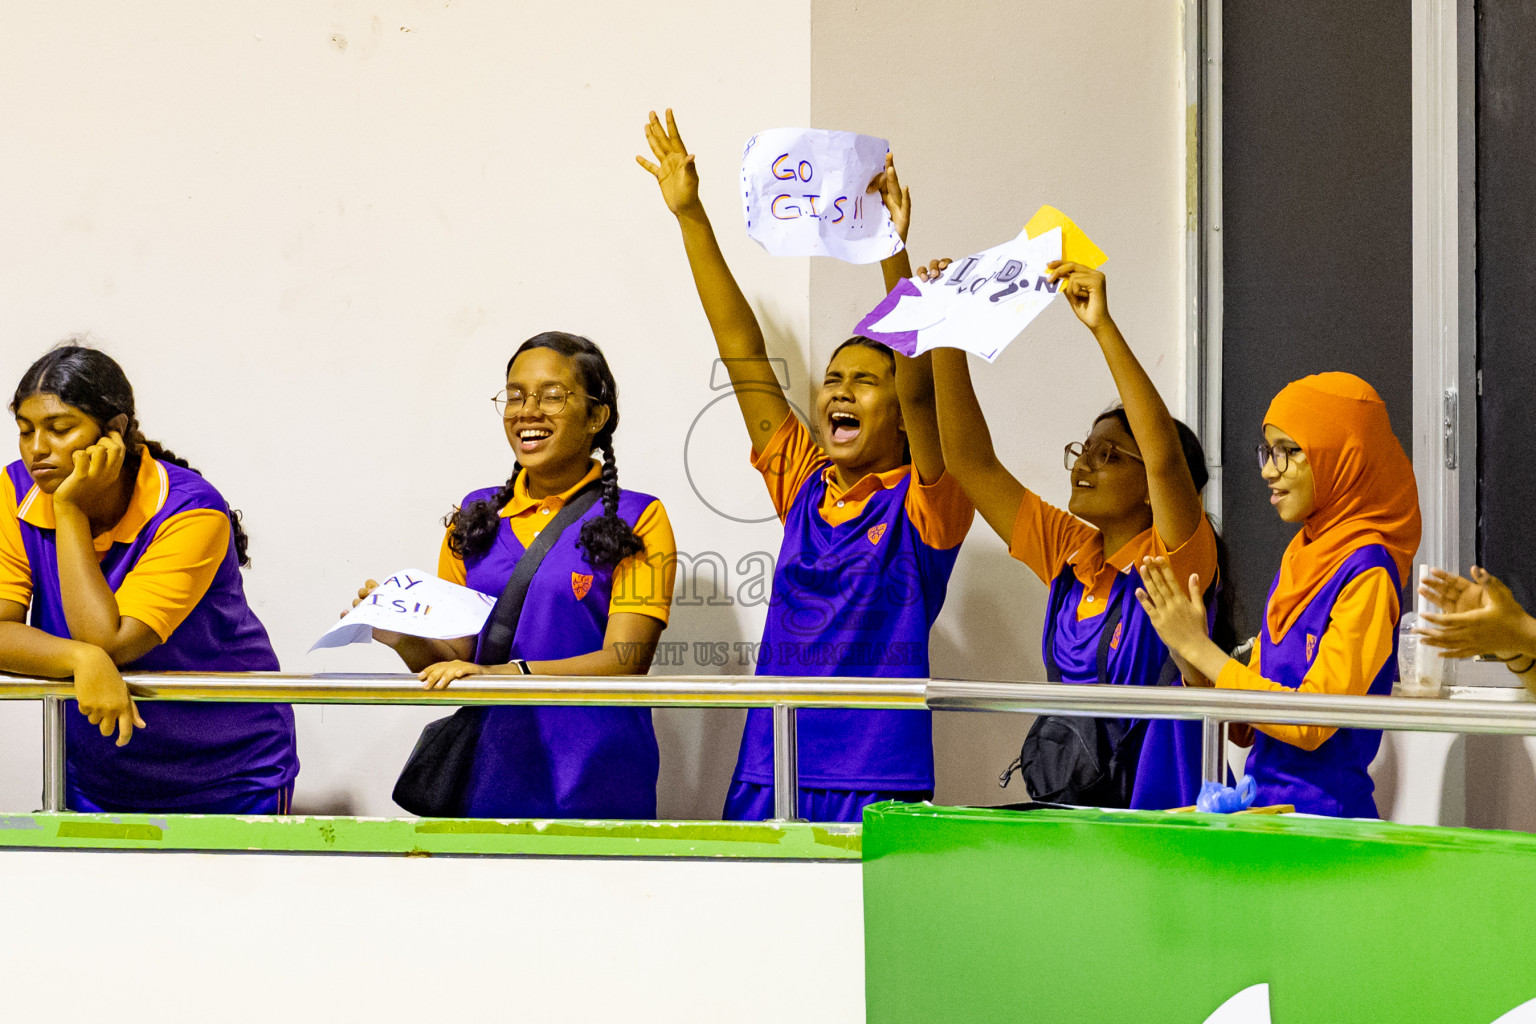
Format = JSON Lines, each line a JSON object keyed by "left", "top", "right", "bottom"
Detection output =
{"left": 742, "top": 127, "right": 902, "bottom": 263}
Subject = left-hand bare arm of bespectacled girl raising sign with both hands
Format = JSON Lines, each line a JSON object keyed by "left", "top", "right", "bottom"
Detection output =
{"left": 914, "top": 348, "right": 1025, "bottom": 543}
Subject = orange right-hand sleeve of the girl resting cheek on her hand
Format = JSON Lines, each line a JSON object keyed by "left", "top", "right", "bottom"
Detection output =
{"left": 117, "top": 508, "right": 230, "bottom": 640}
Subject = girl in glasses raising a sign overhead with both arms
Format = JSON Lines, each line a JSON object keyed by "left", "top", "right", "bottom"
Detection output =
{"left": 919, "top": 259, "right": 1232, "bottom": 808}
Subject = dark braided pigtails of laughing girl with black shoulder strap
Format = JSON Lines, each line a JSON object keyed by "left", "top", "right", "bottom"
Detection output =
{"left": 444, "top": 330, "right": 645, "bottom": 571}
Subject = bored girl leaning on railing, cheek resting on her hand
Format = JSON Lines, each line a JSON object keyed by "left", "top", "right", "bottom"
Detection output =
{"left": 0, "top": 345, "right": 298, "bottom": 814}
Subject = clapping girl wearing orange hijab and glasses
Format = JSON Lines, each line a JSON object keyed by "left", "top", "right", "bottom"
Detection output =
{"left": 1137, "top": 373, "right": 1421, "bottom": 818}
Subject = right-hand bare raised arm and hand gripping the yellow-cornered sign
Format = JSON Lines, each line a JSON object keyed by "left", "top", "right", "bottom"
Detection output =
{"left": 1049, "top": 261, "right": 1206, "bottom": 551}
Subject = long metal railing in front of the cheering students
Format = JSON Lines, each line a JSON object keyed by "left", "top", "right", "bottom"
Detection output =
{"left": 0, "top": 672, "right": 1536, "bottom": 820}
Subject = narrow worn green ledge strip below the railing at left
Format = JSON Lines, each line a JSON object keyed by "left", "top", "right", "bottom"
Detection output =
{"left": 0, "top": 814, "right": 860, "bottom": 860}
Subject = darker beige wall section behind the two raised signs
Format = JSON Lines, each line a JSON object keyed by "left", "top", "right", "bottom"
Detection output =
{"left": 811, "top": 0, "right": 1184, "bottom": 803}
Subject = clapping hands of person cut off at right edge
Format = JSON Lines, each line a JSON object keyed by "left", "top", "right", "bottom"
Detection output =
{"left": 1415, "top": 565, "right": 1536, "bottom": 659}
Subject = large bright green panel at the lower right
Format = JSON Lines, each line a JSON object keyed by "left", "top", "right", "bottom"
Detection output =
{"left": 863, "top": 803, "right": 1536, "bottom": 1024}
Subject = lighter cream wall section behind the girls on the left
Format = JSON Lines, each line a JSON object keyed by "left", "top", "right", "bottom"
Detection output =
{"left": 0, "top": 0, "right": 809, "bottom": 815}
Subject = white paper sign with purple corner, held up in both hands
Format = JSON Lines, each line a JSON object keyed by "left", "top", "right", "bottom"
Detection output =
{"left": 854, "top": 227, "right": 1061, "bottom": 362}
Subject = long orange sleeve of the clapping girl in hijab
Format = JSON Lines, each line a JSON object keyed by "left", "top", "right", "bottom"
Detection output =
{"left": 1217, "top": 568, "right": 1398, "bottom": 751}
